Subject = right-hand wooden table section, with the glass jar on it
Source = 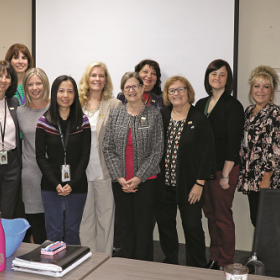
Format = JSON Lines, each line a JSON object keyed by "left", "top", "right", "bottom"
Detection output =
{"left": 85, "top": 258, "right": 279, "bottom": 280}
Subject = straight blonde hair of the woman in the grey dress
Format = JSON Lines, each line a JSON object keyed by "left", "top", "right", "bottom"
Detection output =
{"left": 22, "top": 68, "right": 50, "bottom": 105}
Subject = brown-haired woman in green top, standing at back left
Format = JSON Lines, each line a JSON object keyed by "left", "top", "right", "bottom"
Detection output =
{"left": 5, "top": 44, "right": 33, "bottom": 106}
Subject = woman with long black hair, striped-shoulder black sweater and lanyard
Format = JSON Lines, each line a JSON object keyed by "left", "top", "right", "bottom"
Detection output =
{"left": 35, "top": 75, "right": 91, "bottom": 244}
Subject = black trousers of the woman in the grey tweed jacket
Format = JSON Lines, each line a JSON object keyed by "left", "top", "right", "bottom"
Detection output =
{"left": 113, "top": 179, "right": 156, "bottom": 261}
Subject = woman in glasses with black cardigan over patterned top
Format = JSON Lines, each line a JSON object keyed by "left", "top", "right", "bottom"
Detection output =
{"left": 156, "top": 76, "right": 215, "bottom": 267}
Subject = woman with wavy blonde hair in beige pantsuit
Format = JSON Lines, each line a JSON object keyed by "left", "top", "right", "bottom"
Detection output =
{"left": 79, "top": 61, "right": 122, "bottom": 256}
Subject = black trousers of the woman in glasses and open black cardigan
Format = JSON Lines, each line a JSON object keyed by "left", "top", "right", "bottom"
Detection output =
{"left": 155, "top": 186, "right": 206, "bottom": 267}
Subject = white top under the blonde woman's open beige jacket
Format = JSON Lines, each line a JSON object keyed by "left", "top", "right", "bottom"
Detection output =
{"left": 86, "top": 110, "right": 103, "bottom": 181}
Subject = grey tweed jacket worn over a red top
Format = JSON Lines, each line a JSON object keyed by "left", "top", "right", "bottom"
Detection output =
{"left": 103, "top": 106, "right": 164, "bottom": 182}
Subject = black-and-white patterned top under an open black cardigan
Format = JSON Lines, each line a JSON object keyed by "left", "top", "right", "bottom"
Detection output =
{"left": 165, "top": 118, "right": 186, "bottom": 187}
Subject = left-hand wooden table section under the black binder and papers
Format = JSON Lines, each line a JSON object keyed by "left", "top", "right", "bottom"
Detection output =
{"left": 0, "top": 243, "right": 109, "bottom": 280}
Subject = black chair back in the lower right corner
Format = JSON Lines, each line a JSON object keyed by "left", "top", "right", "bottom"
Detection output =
{"left": 246, "top": 189, "right": 280, "bottom": 277}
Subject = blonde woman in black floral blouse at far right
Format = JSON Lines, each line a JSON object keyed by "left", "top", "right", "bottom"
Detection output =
{"left": 237, "top": 66, "right": 280, "bottom": 226}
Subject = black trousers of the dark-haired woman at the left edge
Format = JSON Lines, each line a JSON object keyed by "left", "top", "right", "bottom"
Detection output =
{"left": 0, "top": 149, "right": 21, "bottom": 219}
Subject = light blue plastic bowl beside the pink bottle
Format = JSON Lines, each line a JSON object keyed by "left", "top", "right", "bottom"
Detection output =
{"left": 1, "top": 218, "right": 30, "bottom": 258}
